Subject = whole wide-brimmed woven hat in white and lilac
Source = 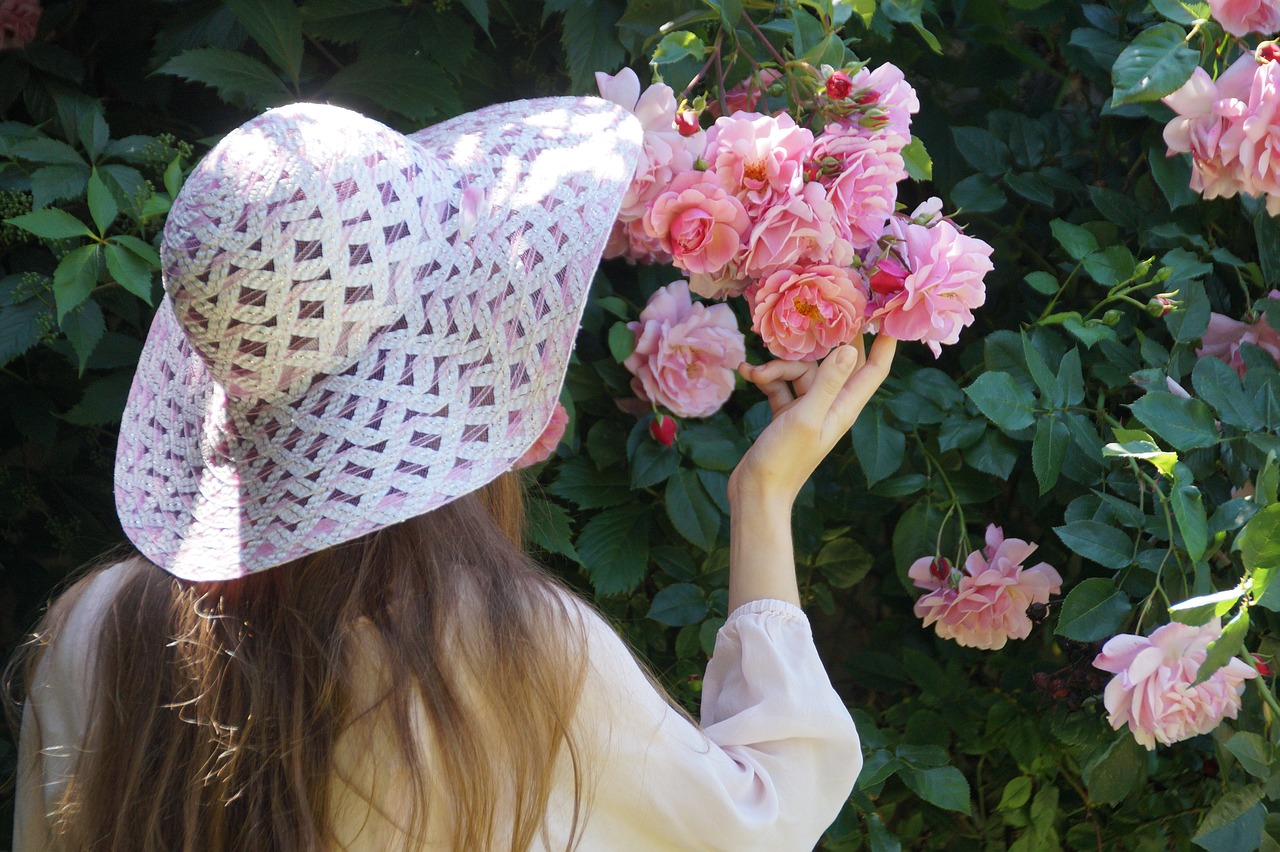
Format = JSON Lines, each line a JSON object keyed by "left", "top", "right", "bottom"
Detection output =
{"left": 115, "top": 99, "right": 641, "bottom": 581}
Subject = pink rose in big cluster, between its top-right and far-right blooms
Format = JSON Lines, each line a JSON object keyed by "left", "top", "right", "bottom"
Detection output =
{"left": 808, "top": 132, "right": 906, "bottom": 249}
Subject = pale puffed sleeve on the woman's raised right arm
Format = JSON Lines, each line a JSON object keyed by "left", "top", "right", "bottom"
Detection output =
{"left": 577, "top": 600, "right": 861, "bottom": 849}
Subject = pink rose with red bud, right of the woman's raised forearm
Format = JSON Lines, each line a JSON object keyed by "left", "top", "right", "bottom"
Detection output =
{"left": 908, "top": 525, "right": 1062, "bottom": 651}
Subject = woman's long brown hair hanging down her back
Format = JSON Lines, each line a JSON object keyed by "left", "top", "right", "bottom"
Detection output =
{"left": 10, "top": 476, "right": 585, "bottom": 852}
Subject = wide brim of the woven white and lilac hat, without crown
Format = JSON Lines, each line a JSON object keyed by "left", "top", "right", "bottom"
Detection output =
{"left": 116, "top": 99, "right": 641, "bottom": 581}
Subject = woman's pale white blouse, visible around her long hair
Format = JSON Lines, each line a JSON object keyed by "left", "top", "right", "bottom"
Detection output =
{"left": 14, "top": 565, "right": 863, "bottom": 852}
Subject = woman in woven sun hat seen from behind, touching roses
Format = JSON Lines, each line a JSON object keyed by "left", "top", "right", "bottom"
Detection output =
{"left": 15, "top": 99, "right": 893, "bottom": 851}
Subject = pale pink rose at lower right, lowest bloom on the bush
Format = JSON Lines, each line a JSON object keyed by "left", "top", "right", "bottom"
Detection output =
{"left": 1093, "top": 619, "right": 1258, "bottom": 750}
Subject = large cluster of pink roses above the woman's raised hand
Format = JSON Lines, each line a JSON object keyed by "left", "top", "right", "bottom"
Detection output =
{"left": 596, "top": 64, "right": 992, "bottom": 417}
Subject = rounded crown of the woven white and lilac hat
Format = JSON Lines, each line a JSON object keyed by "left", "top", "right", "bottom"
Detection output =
{"left": 163, "top": 105, "right": 460, "bottom": 403}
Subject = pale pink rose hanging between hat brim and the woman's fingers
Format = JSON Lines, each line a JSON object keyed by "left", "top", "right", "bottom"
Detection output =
{"left": 622, "top": 281, "right": 746, "bottom": 417}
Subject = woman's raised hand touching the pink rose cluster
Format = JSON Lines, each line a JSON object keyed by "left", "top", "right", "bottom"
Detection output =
{"left": 730, "top": 335, "right": 897, "bottom": 507}
